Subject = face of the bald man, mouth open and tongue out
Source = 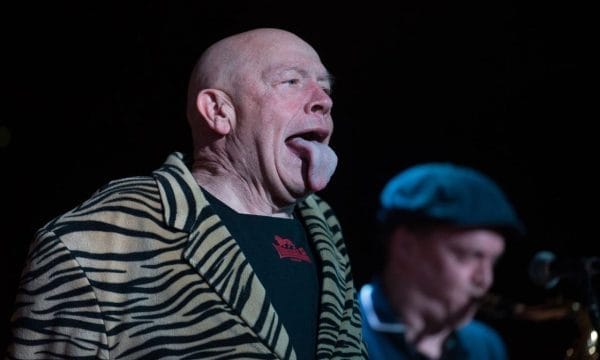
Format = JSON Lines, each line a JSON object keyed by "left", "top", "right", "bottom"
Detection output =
{"left": 228, "top": 37, "right": 337, "bottom": 205}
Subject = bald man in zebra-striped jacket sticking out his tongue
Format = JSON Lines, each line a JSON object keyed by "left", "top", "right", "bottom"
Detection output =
{"left": 8, "top": 29, "right": 366, "bottom": 360}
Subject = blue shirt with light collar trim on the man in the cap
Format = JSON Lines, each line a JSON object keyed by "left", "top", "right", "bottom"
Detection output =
{"left": 359, "top": 281, "right": 507, "bottom": 360}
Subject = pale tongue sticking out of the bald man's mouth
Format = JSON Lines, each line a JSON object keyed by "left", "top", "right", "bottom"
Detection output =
{"left": 288, "top": 137, "right": 337, "bottom": 191}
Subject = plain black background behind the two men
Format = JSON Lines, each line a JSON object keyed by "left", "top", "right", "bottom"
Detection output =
{"left": 0, "top": 0, "right": 599, "bottom": 359}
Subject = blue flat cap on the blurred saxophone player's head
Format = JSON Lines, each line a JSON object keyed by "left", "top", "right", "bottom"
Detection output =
{"left": 380, "top": 163, "right": 525, "bottom": 237}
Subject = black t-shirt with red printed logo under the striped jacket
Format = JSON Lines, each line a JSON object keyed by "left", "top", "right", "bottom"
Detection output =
{"left": 204, "top": 191, "right": 319, "bottom": 360}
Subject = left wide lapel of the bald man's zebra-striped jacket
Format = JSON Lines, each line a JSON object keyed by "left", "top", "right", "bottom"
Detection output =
{"left": 154, "top": 153, "right": 296, "bottom": 359}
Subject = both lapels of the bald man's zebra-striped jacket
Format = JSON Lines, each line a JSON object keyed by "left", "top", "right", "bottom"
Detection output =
{"left": 153, "top": 152, "right": 350, "bottom": 358}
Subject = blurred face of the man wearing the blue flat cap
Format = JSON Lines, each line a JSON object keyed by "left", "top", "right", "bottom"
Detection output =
{"left": 415, "top": 228, "right": 505, "bottom": 326}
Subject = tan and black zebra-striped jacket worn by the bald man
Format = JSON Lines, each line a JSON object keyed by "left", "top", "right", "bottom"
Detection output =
{"left": 8, "top": 153, "right": 366, "bottom": 359}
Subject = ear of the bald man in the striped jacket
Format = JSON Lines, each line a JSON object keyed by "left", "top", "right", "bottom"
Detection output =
{"left": 196, "top": 89, "right": 235, "bottom": 136}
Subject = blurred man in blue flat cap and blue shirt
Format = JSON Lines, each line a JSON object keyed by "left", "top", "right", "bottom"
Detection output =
{"left": 359, "top": 163, "right": 523, "bottom": 360}
